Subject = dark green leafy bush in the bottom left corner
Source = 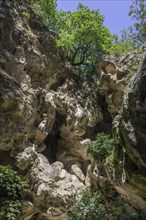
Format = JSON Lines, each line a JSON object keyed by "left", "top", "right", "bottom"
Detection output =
{"left": 0, "top": 166, "right": 29, "bottom": 220}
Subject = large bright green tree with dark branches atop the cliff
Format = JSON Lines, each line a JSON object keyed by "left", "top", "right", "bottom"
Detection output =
{"left": 57, "top": 4, "right": 112, "bottom": 75}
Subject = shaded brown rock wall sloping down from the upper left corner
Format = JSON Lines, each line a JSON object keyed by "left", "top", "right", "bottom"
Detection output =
{"left": 0, "top": 1, "right": 72, "bottom": 155}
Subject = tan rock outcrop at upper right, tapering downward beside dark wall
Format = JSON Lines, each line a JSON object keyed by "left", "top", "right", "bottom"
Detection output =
{"left": 97, "top": 51, "right": 143, "bottom": 118}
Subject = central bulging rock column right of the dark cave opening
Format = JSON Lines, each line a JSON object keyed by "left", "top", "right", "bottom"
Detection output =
{"left": 46, "top": 80, "right": 103, "bottom": 170}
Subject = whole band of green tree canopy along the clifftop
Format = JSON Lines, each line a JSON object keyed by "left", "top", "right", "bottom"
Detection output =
{"left": 32, "top": 0, "right": 146, "bottom": 76}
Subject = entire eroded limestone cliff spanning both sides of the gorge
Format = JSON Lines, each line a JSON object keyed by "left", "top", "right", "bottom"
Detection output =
{"left": 0, "top": 0, "right": 146, "bottom": 220}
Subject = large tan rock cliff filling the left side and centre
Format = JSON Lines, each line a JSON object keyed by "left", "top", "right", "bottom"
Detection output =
{"left": 0, "top": 0, "right": 104, "bottom": 220}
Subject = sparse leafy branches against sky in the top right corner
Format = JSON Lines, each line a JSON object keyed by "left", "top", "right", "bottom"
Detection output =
{"left": 129, "top": 0, "right": 146, "bottom": 44}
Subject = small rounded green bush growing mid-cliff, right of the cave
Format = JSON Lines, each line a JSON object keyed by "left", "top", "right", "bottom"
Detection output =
{"left": 87, "top": 133, "right": 118, "bottom": 161}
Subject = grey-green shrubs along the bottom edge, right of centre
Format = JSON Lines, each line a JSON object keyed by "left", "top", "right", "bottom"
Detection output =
{"left": 66, "top": 185, "right": 145, "bottom": 220}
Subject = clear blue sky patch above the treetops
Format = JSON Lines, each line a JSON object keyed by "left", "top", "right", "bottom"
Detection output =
{"left": 57, "top": 0, "right": 133, "bottom": 34}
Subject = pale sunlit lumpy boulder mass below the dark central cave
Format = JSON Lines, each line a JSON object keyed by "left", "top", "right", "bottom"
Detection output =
{"left": 28, "top": 154, "right": 84, "bottom": 209}
